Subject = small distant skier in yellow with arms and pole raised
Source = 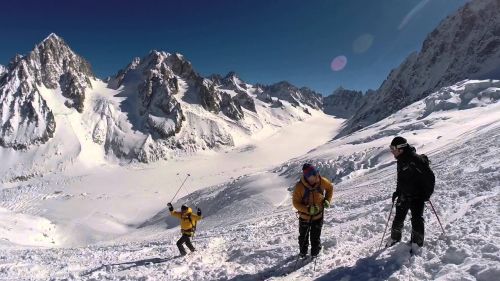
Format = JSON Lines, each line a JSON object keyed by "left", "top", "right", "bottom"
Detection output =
{"left": 167, "top": 203, "right": 202, "bottom": 256}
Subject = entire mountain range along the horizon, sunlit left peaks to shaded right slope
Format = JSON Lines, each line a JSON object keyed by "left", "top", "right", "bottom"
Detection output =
{"left": 0, "top": 0, "right": 500, "bottom": 162}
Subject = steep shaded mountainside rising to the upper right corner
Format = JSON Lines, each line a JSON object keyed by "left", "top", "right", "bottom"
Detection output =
{"left": 339, "top": 0, "right": 500, "bottom": 136}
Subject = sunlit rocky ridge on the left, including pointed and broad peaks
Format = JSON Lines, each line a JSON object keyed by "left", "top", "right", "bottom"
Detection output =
{"left": 0, "top": 34, "right": 332, "bottom": 162}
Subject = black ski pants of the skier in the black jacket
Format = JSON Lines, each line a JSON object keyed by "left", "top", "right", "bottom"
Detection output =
{"left": 391, "top": 197, "right": 425, "bottom": 247}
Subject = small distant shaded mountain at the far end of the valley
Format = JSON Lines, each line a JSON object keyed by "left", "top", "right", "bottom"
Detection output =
{"left": 323, "top": 87, "right": 371, "bottom": 119}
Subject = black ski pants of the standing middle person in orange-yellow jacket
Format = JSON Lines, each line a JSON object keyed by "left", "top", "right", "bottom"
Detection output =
{"left": 299, "top": 217, "right": 323, "bottom": 256}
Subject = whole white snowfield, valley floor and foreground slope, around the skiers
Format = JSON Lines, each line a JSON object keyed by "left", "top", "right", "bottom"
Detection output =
{"left": 0, "top": 80, "right": 500, "bottom": 281}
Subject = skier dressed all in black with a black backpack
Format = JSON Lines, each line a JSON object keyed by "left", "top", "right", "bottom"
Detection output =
{"left": 386, "top": 137, "right": 434, "bottom": 248}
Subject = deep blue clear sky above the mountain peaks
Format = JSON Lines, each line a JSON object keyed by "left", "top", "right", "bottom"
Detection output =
{"left": 0, "top": 0, "right": 467, "bottom": 94}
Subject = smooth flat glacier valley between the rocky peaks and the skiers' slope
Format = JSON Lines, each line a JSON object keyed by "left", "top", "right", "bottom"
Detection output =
{"left": 0, "top": 109, "right": 343, "bottom": 245}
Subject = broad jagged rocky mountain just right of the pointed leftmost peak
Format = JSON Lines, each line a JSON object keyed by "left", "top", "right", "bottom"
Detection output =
{"left": 99, "top": 51, "right": 328, "bottom": 162}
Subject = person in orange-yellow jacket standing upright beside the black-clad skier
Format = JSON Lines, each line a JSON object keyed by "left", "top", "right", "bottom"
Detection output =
{"left": 293, "top": 164, "right": 333, "bottom": 258}
